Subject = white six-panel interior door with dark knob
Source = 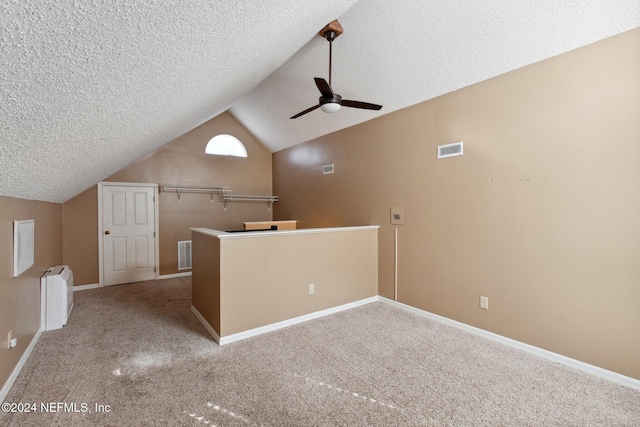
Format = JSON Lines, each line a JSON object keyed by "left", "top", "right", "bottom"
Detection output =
{"left": 102, "top": 185, "right": 156, "bottom": 286}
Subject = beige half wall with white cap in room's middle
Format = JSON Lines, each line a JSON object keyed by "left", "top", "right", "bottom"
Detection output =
{"left": 192, "top": 227, "right": 378, "bottom": 338}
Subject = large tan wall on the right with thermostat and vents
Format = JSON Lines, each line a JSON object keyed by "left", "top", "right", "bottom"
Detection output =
{"left": 273, "top": 29, "right": 640, "bottom": 379}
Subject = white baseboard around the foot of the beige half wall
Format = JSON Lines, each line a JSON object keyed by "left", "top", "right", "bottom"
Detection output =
{"left": 191, "top": 295, "right": 378, "bottom": 346}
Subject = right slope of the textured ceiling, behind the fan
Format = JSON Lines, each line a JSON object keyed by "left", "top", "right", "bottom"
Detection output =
{"left": 231, "top": 0, "right": 640, "bottom": 152}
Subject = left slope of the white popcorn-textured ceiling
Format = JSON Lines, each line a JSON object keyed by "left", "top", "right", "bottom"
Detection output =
{"left": 0, "top": 0, "right": 355, "bottom": 202}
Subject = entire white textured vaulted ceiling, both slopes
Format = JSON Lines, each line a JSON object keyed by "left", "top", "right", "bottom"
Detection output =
{"left": 0, "top": 0, "right": 640, "bottom": 202}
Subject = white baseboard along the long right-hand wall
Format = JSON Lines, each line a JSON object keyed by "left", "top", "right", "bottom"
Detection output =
{"left": 380, "top": 297, "right": 640, "bottom": 390}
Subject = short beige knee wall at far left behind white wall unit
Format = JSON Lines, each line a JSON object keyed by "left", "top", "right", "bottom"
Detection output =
{"left": 0, "top": 196, "right": 62, "bottom": 387}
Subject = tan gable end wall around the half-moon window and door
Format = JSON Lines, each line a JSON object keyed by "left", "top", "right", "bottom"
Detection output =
{"left": 64, "top": 113, "right": 272, "bottom": 285}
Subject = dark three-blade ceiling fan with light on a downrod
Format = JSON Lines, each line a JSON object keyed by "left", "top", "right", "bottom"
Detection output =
{"left": 290, "top": 20, "right": 382, "bottom": 119}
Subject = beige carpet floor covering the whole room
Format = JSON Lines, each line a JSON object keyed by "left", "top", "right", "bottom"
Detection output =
{"left": 0, "top": 278, "right": 640, "bottom": 426}
